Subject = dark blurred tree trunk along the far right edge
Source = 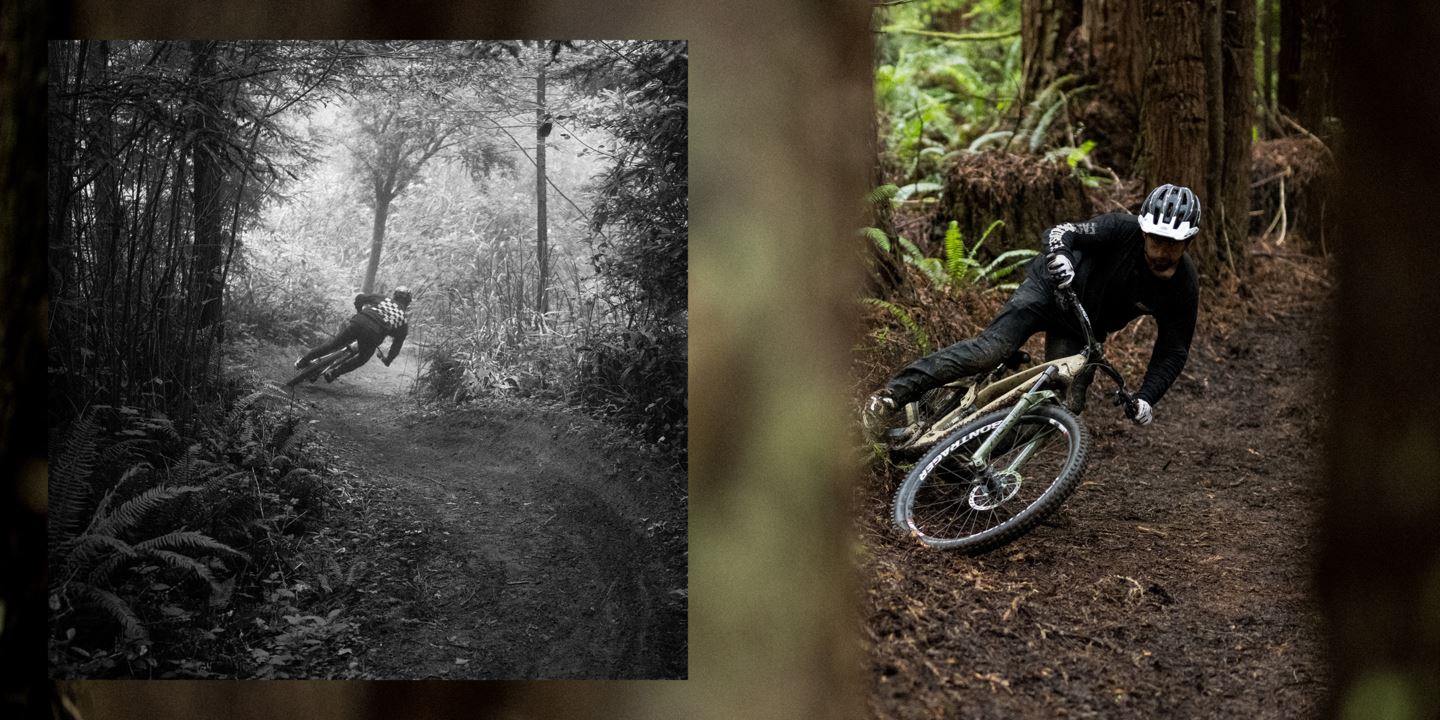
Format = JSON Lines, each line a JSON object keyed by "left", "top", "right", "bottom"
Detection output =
{"left": 1318, "top": 3, "right": 1440, "bottom": 719}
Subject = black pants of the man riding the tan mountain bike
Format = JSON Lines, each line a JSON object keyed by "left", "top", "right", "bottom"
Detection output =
{"left": 886, "top": 275, "right": 1092, "bottom": 410}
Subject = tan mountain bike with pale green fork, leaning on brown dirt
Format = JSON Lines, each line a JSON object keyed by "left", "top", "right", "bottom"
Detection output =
{"left": 886, "top": 288, "right": 1136, "bottom": 554}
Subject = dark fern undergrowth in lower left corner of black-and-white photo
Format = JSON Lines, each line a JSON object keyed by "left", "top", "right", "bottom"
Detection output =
{"left": 49, "top": 380, "right": 347, "bottom": 678}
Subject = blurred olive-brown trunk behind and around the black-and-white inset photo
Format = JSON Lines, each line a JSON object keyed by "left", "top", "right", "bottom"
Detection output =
{"left": 61, "top": 0, "right": 873, "bottom": 720}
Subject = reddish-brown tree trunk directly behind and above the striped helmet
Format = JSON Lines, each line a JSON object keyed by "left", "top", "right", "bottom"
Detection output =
{"left": 1139, "top": 0, "right": 1217, "bottom": 278}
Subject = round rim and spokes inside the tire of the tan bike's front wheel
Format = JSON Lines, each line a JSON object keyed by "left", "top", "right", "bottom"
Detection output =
{"left": 906, "top": 415, "right": 1074, "bottom": 543}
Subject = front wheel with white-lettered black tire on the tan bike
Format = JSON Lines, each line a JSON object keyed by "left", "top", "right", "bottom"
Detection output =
{"left": 894, "top": 405, "right": 1089, "bottom": 554}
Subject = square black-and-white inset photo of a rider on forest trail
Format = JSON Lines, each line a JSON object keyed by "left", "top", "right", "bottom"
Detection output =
{"left": 46, "top": 40, "right": 690, "bottom": 680}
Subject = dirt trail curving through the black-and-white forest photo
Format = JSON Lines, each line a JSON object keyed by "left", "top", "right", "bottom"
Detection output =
{"left": 237, "top": 348, "right": 688, "bottom": 678}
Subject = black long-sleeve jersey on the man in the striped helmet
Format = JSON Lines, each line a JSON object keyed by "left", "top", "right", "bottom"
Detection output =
{"left": 1030, "top": 213, "right": 1200, "bottom": 405}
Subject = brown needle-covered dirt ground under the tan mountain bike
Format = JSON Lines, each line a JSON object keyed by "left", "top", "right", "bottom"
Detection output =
{"left": 861, "top": 253, "right": 1331, "bottom": 719}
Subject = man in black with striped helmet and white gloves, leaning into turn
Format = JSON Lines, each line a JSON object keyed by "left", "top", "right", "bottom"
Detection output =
{"left": 864, "top": 184, "right": 1200, "bottom": 433}
